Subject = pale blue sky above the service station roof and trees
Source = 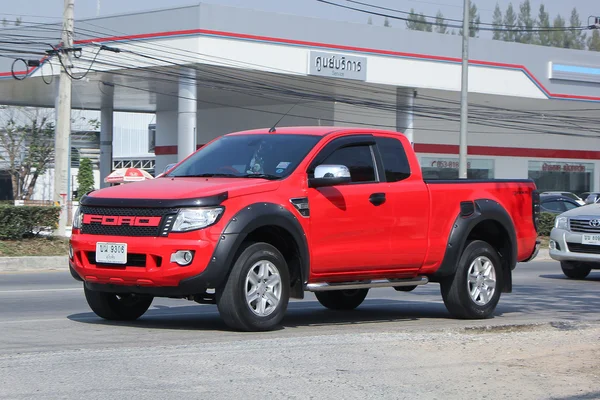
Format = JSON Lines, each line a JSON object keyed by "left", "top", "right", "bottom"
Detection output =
{"left": 0, "top": 0, "right": 600, "bottom": 27}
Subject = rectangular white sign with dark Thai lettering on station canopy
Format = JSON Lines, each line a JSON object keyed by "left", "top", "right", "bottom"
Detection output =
{"left": 308, "top": 51, "right": 367, "bottom": 81}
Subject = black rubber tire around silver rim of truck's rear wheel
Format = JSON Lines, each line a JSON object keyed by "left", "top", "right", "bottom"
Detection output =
{"left": 440, "top": 240, "right": 503, "bottom": 319}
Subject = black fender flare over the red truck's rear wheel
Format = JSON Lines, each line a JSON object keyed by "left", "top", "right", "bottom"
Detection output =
{"left": 430, "top": 199, "right": 517, "bottom": 292}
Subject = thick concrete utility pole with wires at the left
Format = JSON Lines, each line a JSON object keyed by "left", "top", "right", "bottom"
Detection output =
{"left": 53, "top": 0, "right": 75, "bottom": 236}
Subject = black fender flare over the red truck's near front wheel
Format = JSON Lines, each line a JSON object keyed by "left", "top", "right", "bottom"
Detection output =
{"left": 196, "top": 203, "right": 309, "bottom": 287}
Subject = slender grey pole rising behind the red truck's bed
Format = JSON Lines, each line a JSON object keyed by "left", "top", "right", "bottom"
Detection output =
{"left": 458, "top": 0, "right": 471, "bottom": 179}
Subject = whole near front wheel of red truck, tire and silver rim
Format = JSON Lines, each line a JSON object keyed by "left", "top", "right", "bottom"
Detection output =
{"left": 217, "top": 243, "right": 290, "bottom": 331}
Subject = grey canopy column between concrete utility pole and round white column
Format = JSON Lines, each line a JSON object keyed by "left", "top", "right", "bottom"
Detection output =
{"left": 100, "top": 83, "right": 115, "bottom": 188}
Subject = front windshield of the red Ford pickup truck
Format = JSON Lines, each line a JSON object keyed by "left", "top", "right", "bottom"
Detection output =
{"left": 166, "top": 134, "right": 321, "bottom": 179}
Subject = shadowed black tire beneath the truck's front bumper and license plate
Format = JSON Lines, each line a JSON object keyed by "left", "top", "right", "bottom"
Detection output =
{"left": 83, "top": 286, "right": 154, "bottom": 321}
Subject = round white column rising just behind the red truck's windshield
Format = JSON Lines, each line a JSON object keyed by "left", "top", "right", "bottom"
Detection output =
{"left": 177, "top": 68, "right": 197, "bottom": 161}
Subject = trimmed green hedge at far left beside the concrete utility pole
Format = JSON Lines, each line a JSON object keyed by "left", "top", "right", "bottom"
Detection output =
{"left": 0, "top": 205, "right": 60, "bottom": 239}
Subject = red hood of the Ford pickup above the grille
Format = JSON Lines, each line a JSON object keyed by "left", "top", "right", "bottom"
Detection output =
{"left": 83, "top": 177, "right": 280, "bottom": 206}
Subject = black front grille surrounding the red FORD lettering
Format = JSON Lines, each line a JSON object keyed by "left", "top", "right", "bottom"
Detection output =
{"left": 81, "top": 206, "right": 178, "bottom": 237}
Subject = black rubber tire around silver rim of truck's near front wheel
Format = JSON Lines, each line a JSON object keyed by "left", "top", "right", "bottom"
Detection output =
{"left": 216, "top": 243, "right": 290, "bottom": 331}
